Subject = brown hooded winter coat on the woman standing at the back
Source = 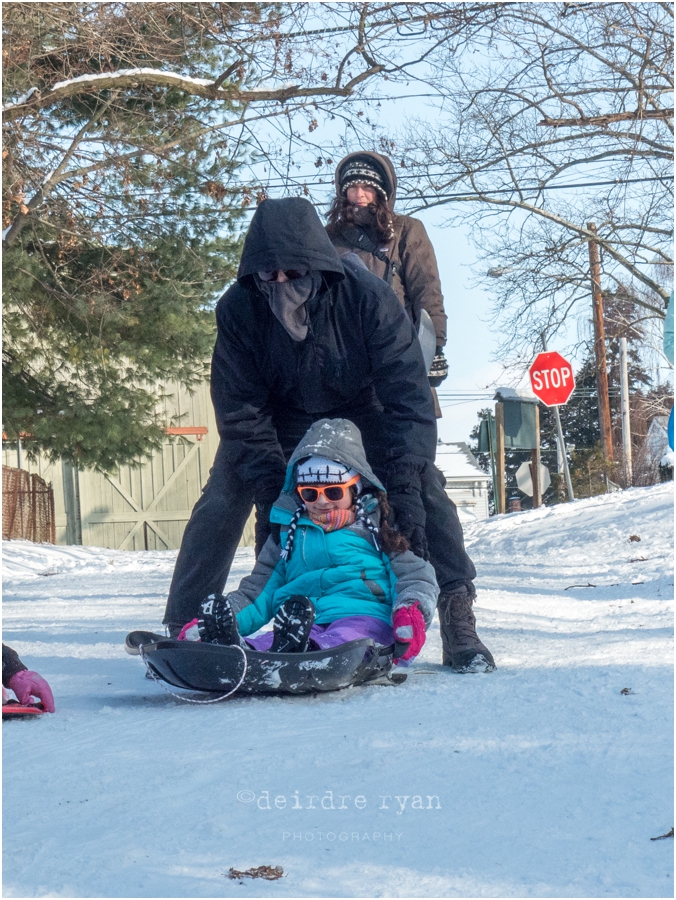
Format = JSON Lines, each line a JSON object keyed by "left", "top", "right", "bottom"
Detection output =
{"left": 329, "top": 151, "right": 446, "bottom": 347}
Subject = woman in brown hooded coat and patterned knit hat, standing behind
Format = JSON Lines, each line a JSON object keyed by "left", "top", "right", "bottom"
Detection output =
{"left": 326, "top": 151, "right": 448, "bottom": 396}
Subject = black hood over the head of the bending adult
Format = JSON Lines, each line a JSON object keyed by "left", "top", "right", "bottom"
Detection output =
{"left": 237, "top": 197, "right": 345, "bottom": 283}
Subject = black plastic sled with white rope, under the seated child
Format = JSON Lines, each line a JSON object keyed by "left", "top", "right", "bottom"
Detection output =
{"left": 135, "top": 638, "right": 406, "bottom": 694}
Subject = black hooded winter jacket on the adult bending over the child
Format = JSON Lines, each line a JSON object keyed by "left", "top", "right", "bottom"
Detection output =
{"left": 211, "top": 198, "right": 436, "bottom": 496}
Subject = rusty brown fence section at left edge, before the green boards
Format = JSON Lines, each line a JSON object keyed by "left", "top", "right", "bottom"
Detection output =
{"left": 2, "top": 466, "right": 56, "bottom": 544}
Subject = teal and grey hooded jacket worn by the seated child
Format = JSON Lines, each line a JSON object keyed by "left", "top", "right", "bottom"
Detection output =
{"left": 228, "top": 419, "right": 439, "bottom": 635}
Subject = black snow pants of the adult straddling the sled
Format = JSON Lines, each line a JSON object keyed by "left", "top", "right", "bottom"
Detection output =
{"left": 163, "top": 409, "right": 476, "bottom": 625}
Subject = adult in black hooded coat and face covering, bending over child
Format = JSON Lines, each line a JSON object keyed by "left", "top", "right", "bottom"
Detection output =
{"left": 164, "top": 198, "right": 493, "bottom": 670}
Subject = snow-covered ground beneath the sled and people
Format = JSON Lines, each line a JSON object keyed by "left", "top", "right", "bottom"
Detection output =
{"left": 3, "top": 485, "right": 673, "bottom": 897}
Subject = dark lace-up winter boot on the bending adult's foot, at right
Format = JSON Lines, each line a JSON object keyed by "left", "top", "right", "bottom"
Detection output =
{"left": 437, "top": 584, "right": 495, "bottom": 673}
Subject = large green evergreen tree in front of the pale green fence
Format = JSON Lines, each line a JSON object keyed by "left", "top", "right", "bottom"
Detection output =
{"left": 3, "top": 3, "right": 252, "bottom": 470}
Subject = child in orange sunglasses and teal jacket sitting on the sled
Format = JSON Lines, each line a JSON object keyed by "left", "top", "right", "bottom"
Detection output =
{"left": 179, "top": 419, "right": 439, "bottom": 665}
